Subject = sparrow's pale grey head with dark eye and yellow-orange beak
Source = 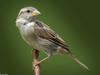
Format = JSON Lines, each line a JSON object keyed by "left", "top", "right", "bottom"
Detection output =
{"left": 17, "top": 7, "right": 40, "bottom": 19}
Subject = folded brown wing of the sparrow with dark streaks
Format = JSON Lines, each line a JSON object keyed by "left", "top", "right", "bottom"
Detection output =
{"left": 34, "top": 21, "right": 69, "bottom": 50}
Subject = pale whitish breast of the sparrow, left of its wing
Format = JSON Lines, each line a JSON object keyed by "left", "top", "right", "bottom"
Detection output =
{"left": 20, "top": 22, "right": 37, "bottom": 46}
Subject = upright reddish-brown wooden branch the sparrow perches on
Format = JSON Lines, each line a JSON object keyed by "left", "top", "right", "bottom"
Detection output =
{"left": 32, "top": 50, "right": 40, "bottom": 75}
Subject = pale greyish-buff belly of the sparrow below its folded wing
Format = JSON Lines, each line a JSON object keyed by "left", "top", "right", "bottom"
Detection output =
{"left": 21, "top": 26, "right": 57, "bottom": 53}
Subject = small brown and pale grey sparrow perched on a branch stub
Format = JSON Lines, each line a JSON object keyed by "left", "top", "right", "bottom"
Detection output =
{"left": 16, "top": 6, "right": 89, "bottom": 70}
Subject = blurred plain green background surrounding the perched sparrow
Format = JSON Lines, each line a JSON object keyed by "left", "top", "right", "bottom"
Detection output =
{"left": 0, "top": 0, "right": 100, "bottom": 75}
